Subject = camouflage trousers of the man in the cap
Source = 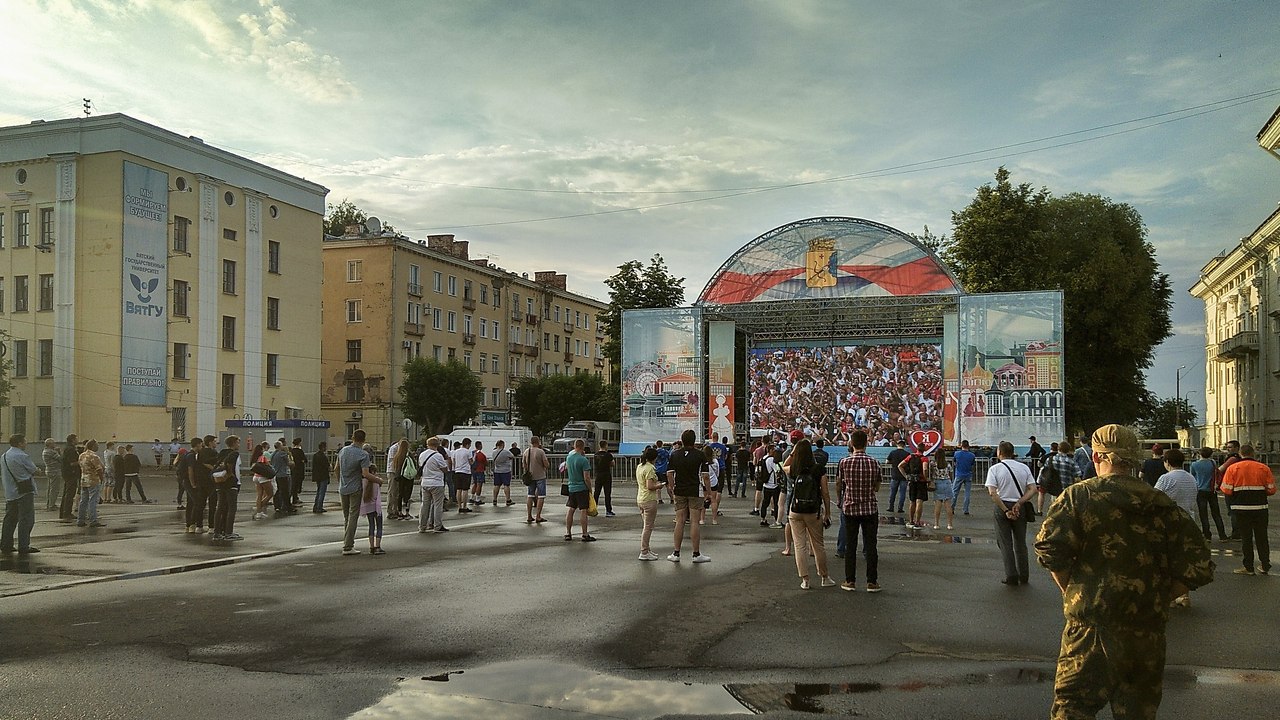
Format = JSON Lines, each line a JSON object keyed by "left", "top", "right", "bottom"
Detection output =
{"left": 1050, "top": 620, "right": 1165, "bottom": 720}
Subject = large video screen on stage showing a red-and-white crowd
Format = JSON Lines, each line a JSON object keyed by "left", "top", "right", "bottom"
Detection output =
{"left": 748, "top": 343, "right": 943, "bottom": 446}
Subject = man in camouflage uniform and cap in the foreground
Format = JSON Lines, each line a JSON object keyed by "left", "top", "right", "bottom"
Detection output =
{"left": 1036, "top": 425, "right": 1213, "bottom": 720}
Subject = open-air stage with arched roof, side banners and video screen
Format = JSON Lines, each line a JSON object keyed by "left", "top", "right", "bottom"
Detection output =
{"left": 621, "top": 217, "right": 1064, "bottom": 459}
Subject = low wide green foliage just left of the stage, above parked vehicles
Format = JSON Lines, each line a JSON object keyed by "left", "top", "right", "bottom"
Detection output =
{"left": 515, "top": 373, "right": 622, "bottom": 436}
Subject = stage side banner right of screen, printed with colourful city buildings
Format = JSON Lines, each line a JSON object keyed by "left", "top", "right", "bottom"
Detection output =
{"left": 957, "top": 291, "right": 1066, "bottom": 447}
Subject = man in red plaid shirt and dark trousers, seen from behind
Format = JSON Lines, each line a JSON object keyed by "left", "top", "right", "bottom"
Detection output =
{"left": 836, "top": 430, "right": 881, "bottom": 592}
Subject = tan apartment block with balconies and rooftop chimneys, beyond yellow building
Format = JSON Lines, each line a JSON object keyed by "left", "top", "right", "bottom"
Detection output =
{"left": 321, "top": 229, "right": 608, "bottom": 448}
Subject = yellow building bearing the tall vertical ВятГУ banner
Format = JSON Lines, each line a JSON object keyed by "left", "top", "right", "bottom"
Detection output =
{"left": 0, "top": 114, "right": 328, "bottom": 441}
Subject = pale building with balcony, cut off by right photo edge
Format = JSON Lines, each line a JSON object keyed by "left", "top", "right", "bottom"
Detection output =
{"left": 1190, "top": 109, "right": 1280, "bottom": 450}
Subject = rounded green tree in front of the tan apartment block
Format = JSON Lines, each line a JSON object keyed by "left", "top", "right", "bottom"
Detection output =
{"left": 399, "top": 357, "right": 484, "bottom": 434}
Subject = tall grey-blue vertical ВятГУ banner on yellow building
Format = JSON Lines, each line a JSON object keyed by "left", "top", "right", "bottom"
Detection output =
{"left": 120, "top": 161, "right": 169, "bottom": 407}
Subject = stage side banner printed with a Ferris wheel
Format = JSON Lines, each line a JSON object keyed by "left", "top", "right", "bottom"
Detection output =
{"left": 620, "top": 307, "right": 704, "bottom": 455}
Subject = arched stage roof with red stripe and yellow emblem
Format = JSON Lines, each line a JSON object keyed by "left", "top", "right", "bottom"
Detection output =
{"left": 695, "top": 217, "right": 964, "bottom": 341}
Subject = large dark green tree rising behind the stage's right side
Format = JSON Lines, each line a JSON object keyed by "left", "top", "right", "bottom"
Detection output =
{"left": 945, "top": 168, "right": 1172, "bottom": 430}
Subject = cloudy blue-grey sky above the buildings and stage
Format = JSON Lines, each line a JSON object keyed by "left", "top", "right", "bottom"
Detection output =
{"left": 0, "top": 0, "right": 1280, "bottom": 416}
